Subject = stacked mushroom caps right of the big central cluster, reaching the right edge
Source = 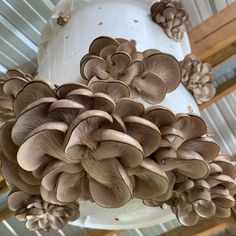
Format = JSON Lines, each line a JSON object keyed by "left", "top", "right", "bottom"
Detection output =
{"left": 144, "top": 107, "right": 236, "bottom": 226}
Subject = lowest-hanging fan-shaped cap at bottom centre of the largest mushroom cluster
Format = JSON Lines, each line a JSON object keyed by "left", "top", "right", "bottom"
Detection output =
{"left": 81, "top": 158, "right": 133, "bottom": 208}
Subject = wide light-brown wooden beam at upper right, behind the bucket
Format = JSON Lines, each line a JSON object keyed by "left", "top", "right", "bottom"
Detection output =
{"left": 189, "top": 3, "right": 236, "bottom": 66}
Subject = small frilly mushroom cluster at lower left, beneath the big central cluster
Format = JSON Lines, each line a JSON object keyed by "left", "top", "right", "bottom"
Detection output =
{"left": 8, "top": 189, "right": 79, "bottom": 231}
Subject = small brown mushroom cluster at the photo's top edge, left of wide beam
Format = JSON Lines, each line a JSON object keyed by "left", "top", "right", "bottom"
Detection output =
{"left": 151, "top": 0, "right": 189, "bottom": 42}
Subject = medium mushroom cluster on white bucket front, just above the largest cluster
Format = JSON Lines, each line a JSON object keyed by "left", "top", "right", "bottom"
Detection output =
{"left": 81, "top": 37, "right": 181, "bottom": 103}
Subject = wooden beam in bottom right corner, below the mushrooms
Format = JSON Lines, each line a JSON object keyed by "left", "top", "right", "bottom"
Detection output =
{"left": 162, "top": 216, "right": 236, "bottom": 236}
